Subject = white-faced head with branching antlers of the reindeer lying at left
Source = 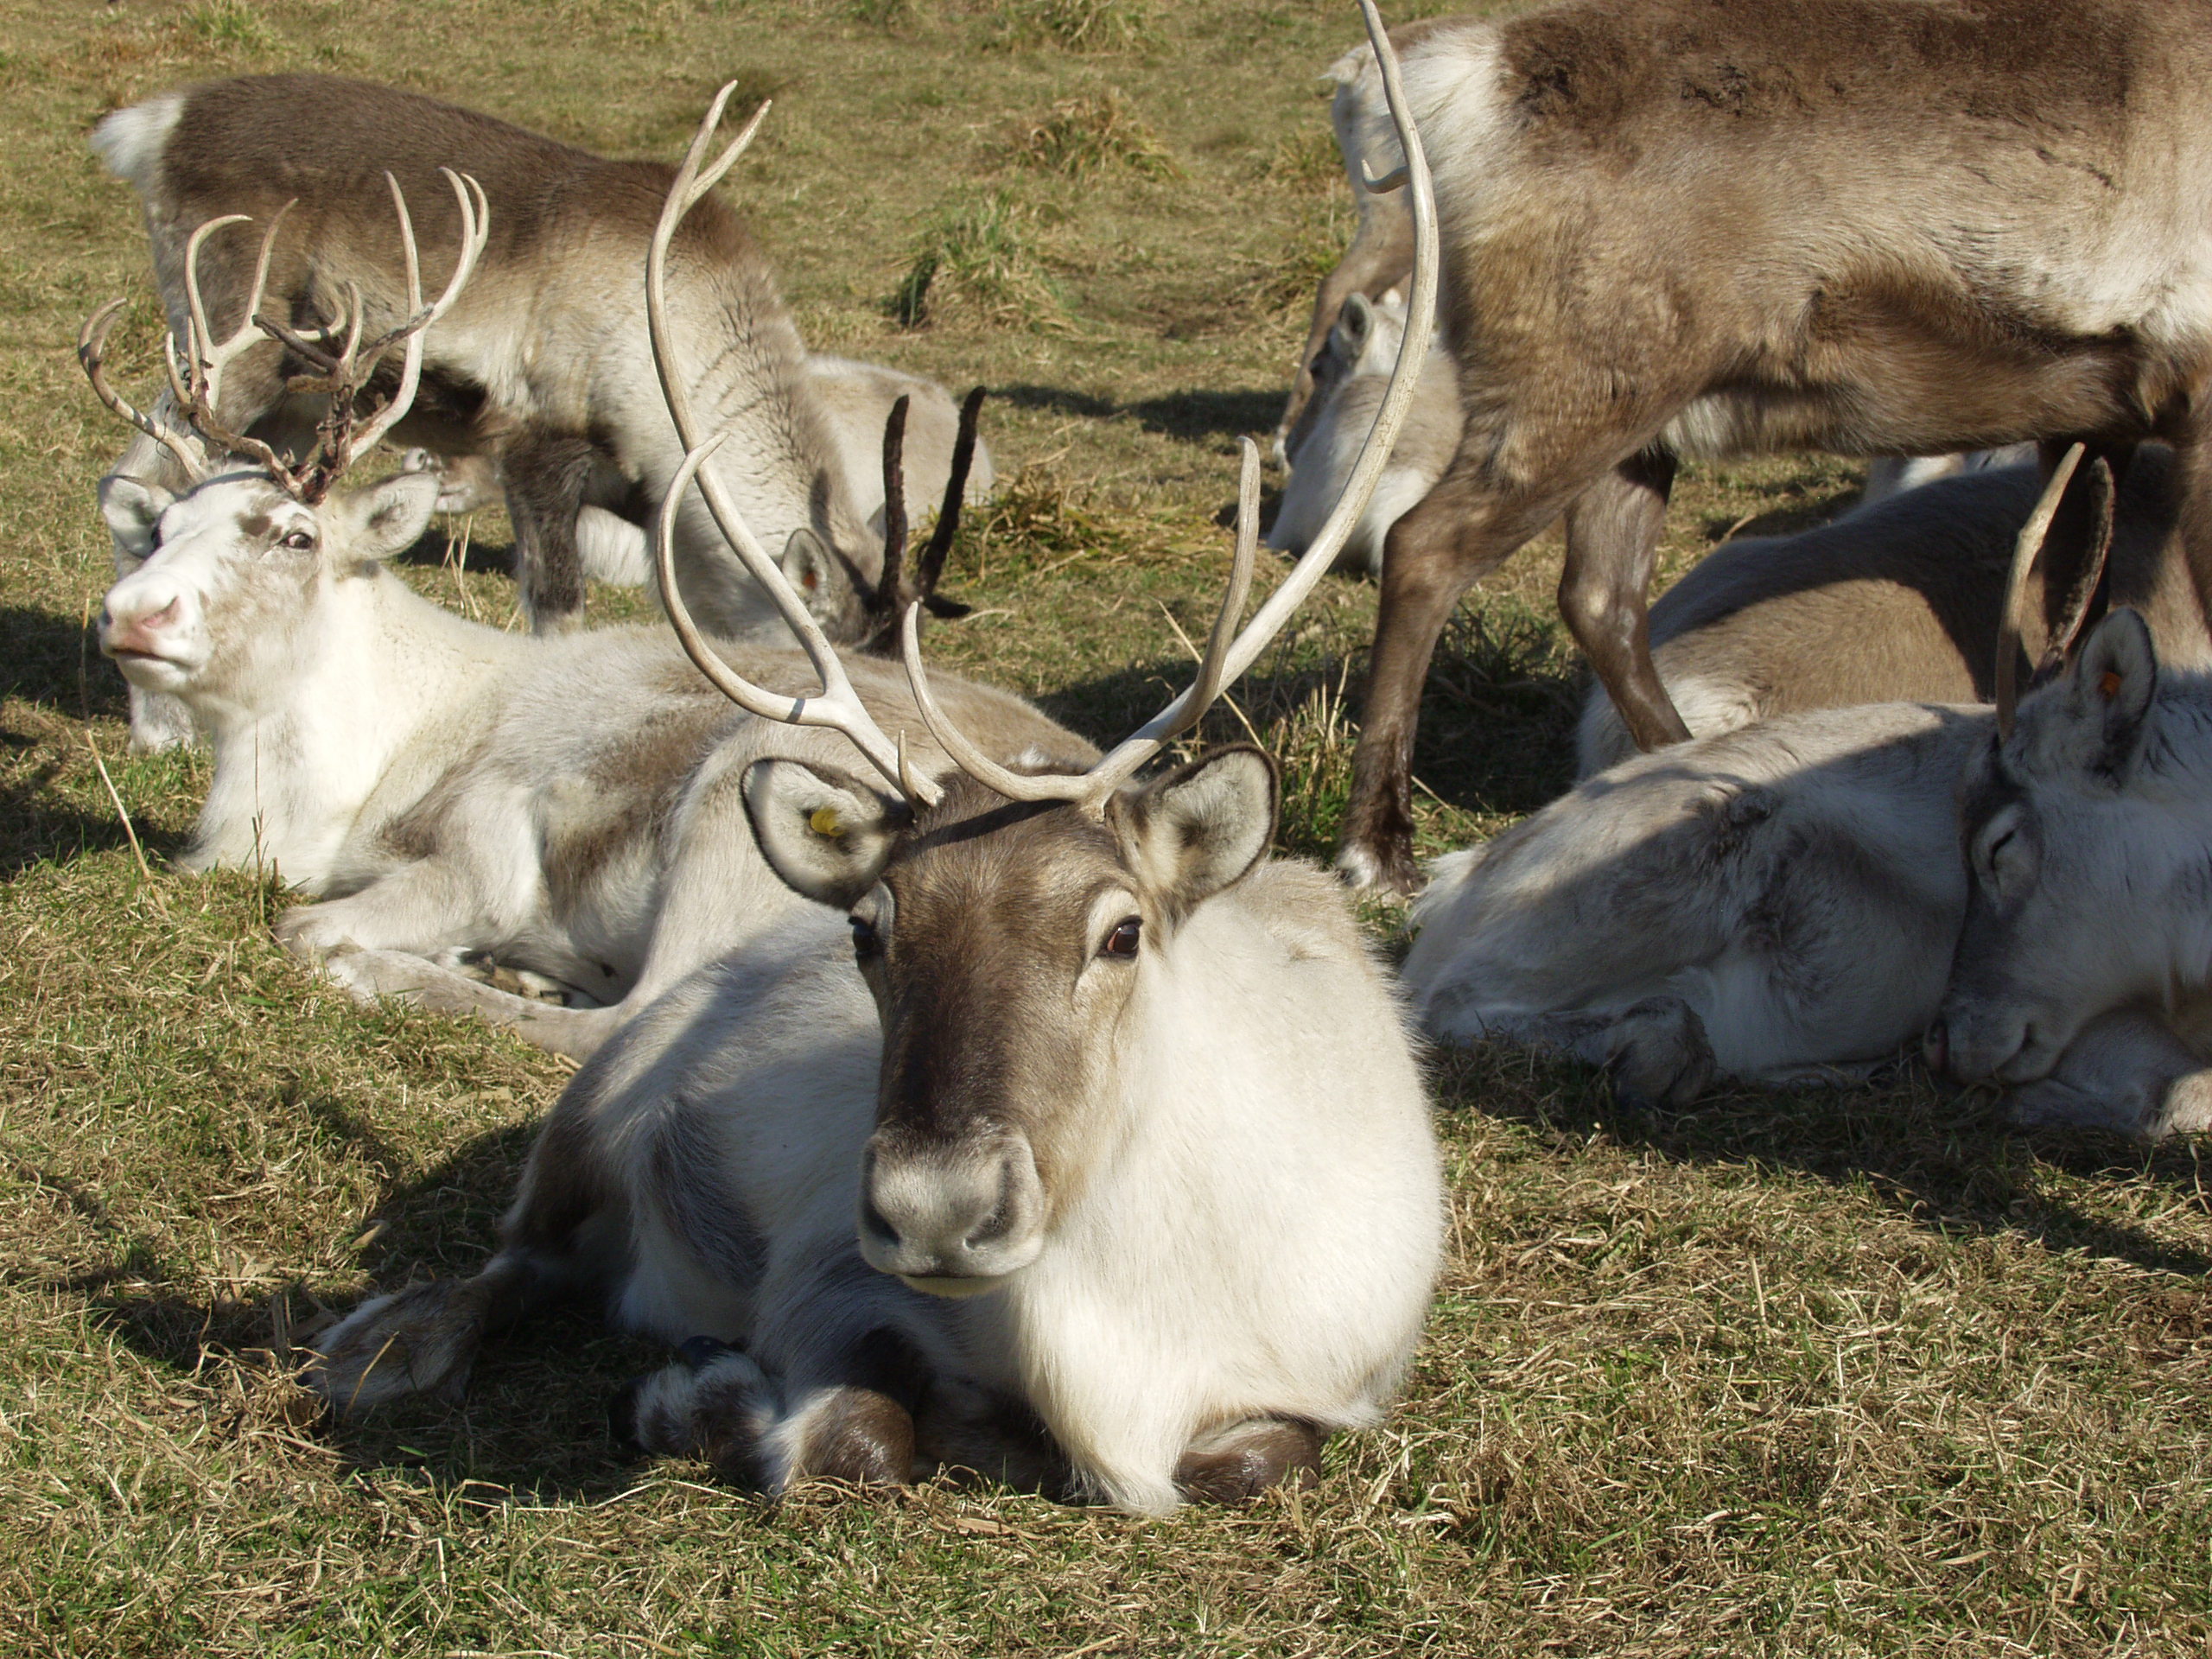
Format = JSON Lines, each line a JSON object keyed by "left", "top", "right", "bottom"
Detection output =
{"left": 78, "top": 170, "right": 489, "bottom": 716}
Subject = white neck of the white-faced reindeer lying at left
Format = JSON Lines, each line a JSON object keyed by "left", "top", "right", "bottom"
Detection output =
{"left": 186, "top": 569, "right": 529, "bottom": 889}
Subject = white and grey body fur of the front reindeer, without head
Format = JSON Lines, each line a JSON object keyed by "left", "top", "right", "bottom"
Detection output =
{"left": 316, "top": 868, "right": 1442, "bottom": 1513}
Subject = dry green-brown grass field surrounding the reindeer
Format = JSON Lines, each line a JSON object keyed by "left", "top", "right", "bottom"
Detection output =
{"left": 0, "top": 0, "right": 2212, "bottom": 1656}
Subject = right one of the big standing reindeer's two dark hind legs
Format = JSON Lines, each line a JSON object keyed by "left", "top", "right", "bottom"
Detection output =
{"left": 1560, "top": 449, "right": 1690, "bottom": 750}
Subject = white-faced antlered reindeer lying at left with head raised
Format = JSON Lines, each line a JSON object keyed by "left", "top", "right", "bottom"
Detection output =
{"left": 79, "top": 181, "right": 1084, "bottom": 1058}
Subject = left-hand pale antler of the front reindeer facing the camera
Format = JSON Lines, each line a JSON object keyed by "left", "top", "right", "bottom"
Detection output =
{"left": 646, "top": 82, "right": 943, "bottom": 805}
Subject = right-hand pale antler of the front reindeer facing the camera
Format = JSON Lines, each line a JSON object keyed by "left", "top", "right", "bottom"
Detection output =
{"left": 902, "top": 0, "right": 1438, "bottom": 814}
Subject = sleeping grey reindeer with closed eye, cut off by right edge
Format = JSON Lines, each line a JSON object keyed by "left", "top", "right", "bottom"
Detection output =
{"left": 1929, "top": 611, "right": 2212, "bottom": 1137}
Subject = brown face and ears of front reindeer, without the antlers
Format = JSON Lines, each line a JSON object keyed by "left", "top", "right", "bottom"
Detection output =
{"left": 743, "top": 747, "right": 1276, "bottom": 1294}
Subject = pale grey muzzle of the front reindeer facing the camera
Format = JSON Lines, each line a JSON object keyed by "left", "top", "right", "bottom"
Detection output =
{"left": 861, "top": 1135, "right": 1044, "bottom": 1296}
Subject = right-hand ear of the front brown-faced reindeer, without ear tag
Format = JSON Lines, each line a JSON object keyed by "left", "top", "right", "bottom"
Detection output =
{"left": 1110, "top": 746, "right": 1276, "bottom": 909}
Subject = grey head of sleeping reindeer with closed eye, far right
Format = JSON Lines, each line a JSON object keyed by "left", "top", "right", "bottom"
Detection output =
{"left": 1929, "top": 611, "right": 2167, "bottom": 1084}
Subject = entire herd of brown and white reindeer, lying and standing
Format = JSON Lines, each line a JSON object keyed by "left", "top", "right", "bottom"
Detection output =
{"left": 60, "top": 0, "right": 2212, "bottom": 1513}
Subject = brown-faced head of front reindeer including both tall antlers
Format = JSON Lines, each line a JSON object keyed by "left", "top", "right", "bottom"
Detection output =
{"left": 648, "top": 0, "right": 1435, "bottom": 1294}
